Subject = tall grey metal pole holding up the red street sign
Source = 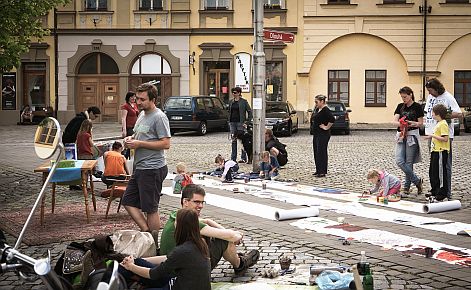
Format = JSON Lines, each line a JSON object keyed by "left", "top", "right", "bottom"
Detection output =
{"left": 252, "top": 0, "right": 265, "bottom": 172}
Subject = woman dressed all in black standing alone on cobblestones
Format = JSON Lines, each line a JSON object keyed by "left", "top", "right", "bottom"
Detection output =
{"left": 310, "top": 95, "right": 335, "bottom": 177}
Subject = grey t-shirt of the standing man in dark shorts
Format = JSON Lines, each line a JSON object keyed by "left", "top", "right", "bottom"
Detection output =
{"left": 134, "top": 108, "right": 171, "bottom": 169}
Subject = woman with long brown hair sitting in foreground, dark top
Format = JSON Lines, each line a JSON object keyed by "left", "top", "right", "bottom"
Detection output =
{"left": 121, "top": 209, "right": 211, "bottom": 290}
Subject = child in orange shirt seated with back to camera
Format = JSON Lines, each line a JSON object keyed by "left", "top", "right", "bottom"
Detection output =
{"left": 101, "top": 141, "right": 129, "bottom": 187}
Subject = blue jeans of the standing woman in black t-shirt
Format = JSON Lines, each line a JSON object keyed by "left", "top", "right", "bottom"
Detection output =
{"left": 396, "top": 137, "right": 420, "bottom": 189}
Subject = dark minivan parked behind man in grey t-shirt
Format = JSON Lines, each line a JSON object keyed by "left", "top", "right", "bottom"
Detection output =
{"left": 164, "top": 96, "right": 228, "bottom": 135}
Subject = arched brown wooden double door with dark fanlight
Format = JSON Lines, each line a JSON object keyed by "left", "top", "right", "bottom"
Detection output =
{"left": 76, "top": 53, "right": 119, "bottom": 122}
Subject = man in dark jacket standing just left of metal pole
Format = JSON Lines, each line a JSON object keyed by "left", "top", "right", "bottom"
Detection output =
{"left": 229, "top": 87, "right": 252, "bottom": 161}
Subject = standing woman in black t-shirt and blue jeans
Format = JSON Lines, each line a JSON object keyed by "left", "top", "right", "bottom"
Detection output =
{"left": 393, "top": 87, "right": 424, "bottom": 195}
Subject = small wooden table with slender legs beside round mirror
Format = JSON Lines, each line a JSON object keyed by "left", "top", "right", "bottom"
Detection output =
{"left": 34, "top": 160, "right": 98, "bottom": 225}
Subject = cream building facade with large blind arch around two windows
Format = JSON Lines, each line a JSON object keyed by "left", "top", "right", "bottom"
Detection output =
{"left": 297, "top": 0, "right": 471, "bottom": 123}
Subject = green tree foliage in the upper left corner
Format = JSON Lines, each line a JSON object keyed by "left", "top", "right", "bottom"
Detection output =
{"left": 0, "top": 0, "right": 69, "bottom": 72}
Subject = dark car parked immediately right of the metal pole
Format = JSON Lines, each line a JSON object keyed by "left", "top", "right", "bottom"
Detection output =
{"left": 265, "top": 101, "right": 299, "bottom": 136}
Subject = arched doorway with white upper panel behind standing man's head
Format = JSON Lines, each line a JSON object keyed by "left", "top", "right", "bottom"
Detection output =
{"left": 129, "top": 53, "right": 172, "bottom": 108}
